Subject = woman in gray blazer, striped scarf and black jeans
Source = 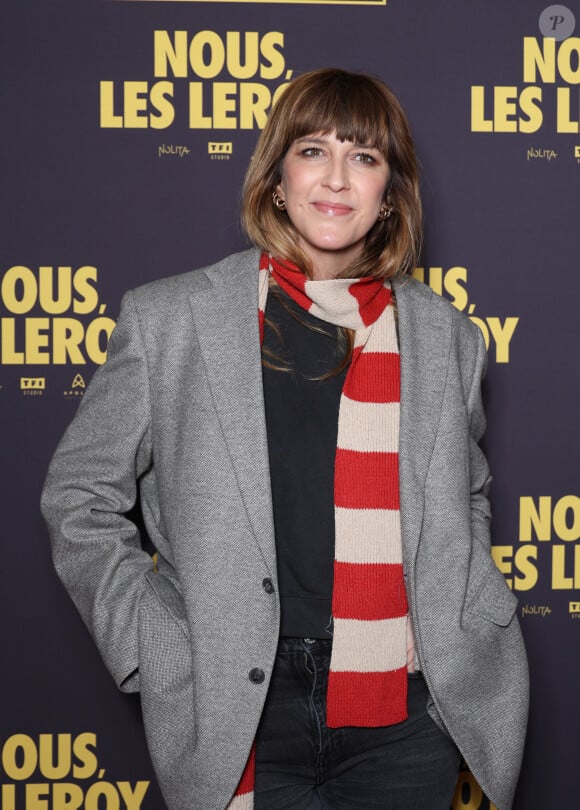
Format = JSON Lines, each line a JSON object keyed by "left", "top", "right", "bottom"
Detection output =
{"left": 43, "top": 69, "right": 527, "bottom": 810}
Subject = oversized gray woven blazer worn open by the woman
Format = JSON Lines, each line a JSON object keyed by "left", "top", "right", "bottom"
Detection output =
{"left": 42, "top": 250, "right": 528, "bottom": 810}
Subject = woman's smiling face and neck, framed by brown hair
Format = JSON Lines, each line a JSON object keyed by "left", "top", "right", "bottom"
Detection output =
{"left": 276, "top": 132, "right": 389, "bottom": 278}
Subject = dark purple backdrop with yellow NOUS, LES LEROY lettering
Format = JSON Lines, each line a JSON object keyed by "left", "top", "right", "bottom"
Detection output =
{"left": 0, "top": 0, "right": 580, "bottom": 810}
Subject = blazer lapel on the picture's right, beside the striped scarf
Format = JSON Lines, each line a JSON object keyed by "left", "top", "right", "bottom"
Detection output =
{"left": 393, "top": 278, "right": 451, "bottom": 576}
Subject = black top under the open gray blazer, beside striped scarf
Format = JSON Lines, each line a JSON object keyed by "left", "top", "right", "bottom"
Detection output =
{"left": 263, "top": 288, "right": 346, "bottom": 638}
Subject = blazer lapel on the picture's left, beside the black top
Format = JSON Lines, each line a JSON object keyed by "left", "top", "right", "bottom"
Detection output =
{"left": 190, "top": 251, "right": 276, "bottom": 577}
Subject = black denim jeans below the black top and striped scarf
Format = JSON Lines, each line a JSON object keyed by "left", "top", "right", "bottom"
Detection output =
{"left": 254, "top": 638, "right": 460, "bottom": 810}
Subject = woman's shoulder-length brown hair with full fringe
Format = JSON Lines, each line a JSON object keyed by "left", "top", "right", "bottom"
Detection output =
{"left": 242, "top": 68, "right": 422, "bottom": 278}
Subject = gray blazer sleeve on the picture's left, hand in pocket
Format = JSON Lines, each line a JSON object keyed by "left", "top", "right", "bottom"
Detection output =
{"left": 41, "top": 293, "right": 153, "bottom": 691}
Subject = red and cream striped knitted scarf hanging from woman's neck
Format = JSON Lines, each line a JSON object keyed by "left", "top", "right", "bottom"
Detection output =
{"left": 228, "top": 253, "right": 408, "bottom": 810}
